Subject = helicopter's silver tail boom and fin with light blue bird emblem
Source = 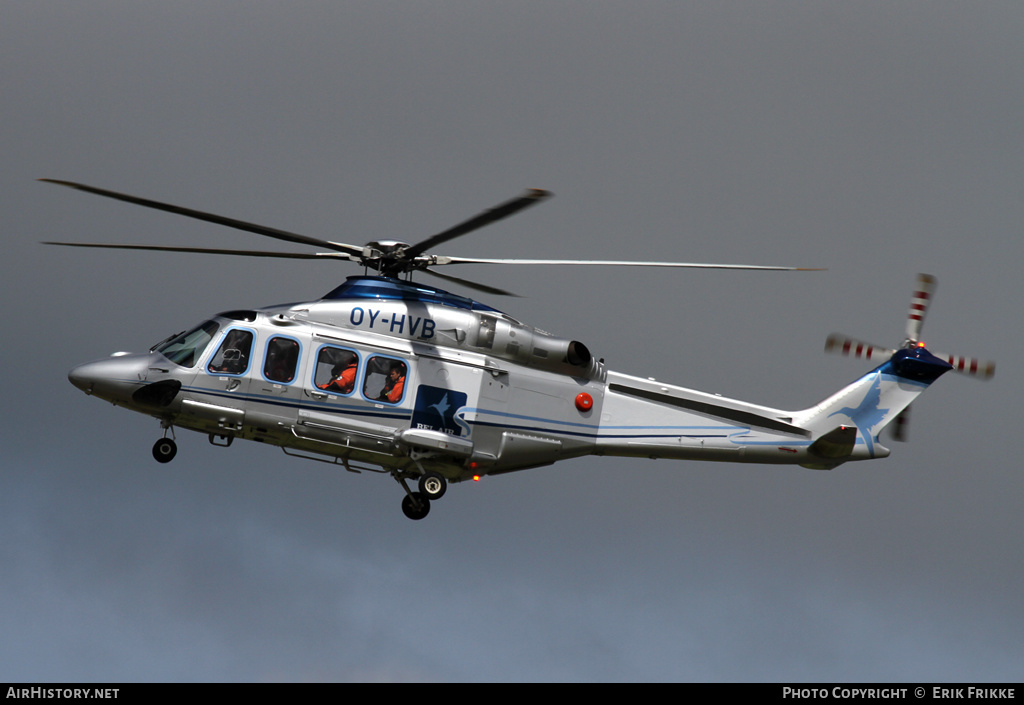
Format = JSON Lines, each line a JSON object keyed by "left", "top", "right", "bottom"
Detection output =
{"left": 591, "top": 346, "right": 952, "bottom": 469}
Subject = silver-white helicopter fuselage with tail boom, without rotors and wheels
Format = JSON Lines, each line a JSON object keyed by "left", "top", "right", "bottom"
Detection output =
{"left": 69, "top": 278, "right": 948, "bottom": 481}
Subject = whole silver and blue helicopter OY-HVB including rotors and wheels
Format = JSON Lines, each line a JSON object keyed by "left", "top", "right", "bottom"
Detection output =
{"left": 40, "top": 179, "right": 995, "bottom": 520}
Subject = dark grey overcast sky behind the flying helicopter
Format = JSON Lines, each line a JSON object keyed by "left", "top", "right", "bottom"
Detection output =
{"left": 0, "top": 0, "right": 1024, "bottom": 681}
